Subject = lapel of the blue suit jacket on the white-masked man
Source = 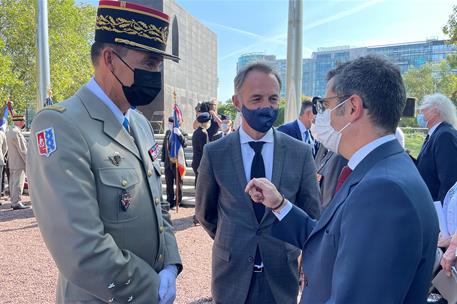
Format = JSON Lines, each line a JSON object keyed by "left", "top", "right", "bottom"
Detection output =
{"left": 305, "top": 140, "right": 403, "bottom": 244}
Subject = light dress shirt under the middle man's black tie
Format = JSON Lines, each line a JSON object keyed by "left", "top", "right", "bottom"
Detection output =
{"left": 240, "top": 126, "right": 274, "bottom": 182}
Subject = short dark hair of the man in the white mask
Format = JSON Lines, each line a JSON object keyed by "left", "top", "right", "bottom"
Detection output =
{"left": 332, "top": 55, "right": 406, "bottom": 133}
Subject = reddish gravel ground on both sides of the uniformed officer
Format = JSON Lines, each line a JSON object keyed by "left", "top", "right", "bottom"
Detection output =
{"left": 0, "top": 197, "right": 212, "bottom": 304}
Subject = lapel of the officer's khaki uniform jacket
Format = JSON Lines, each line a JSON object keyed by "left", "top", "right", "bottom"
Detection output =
{"left": 76, "top": 86, "right": 141, "bottom": 159}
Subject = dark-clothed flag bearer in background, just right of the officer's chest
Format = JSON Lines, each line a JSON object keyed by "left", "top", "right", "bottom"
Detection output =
{"left": 162, "top": 116, "right": 187, "bottom": 209}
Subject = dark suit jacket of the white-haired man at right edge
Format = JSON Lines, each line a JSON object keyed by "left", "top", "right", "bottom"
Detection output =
{"left": 417, "top": 122, "right": 457, "bottom": 202}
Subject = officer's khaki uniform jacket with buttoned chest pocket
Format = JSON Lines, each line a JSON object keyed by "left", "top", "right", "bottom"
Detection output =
{"left": 27, "top": 87, "right": 182, "bottom": 304}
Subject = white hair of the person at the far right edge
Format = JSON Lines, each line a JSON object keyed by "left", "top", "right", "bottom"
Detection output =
{"left": 419, "top": 93, "right": 457, "bottom": 128}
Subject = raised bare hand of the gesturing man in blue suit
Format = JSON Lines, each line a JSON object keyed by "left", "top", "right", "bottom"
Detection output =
{"left": 244, "top": 178, "right": 282, "bottom": 209}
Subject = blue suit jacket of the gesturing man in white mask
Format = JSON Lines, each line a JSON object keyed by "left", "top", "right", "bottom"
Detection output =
{"left": 273, "top": 140, "right": 439, "bottom": 304}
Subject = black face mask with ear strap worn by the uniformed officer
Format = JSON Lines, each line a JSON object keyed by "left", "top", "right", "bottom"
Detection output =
{"left": 111, "top": 51, "right": 162, "bottom": 107}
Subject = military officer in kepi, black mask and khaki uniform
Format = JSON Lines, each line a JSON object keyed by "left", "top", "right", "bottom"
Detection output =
{"left": 28, "top": 1, "right": 182, "bottom": 304}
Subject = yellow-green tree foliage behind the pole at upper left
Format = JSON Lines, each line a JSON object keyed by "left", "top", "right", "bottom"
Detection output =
{"left": 0, "top": 0, "right": 96, "bottom": 112}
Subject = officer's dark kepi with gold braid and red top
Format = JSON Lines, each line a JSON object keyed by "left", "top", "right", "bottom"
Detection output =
{"left": 95, "top": 0, "right": 179, "bottom": 60}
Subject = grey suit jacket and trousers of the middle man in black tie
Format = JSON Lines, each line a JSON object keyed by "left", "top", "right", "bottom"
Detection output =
{"left": 195, "top": 130, "right": 320, "bottom": 304}
